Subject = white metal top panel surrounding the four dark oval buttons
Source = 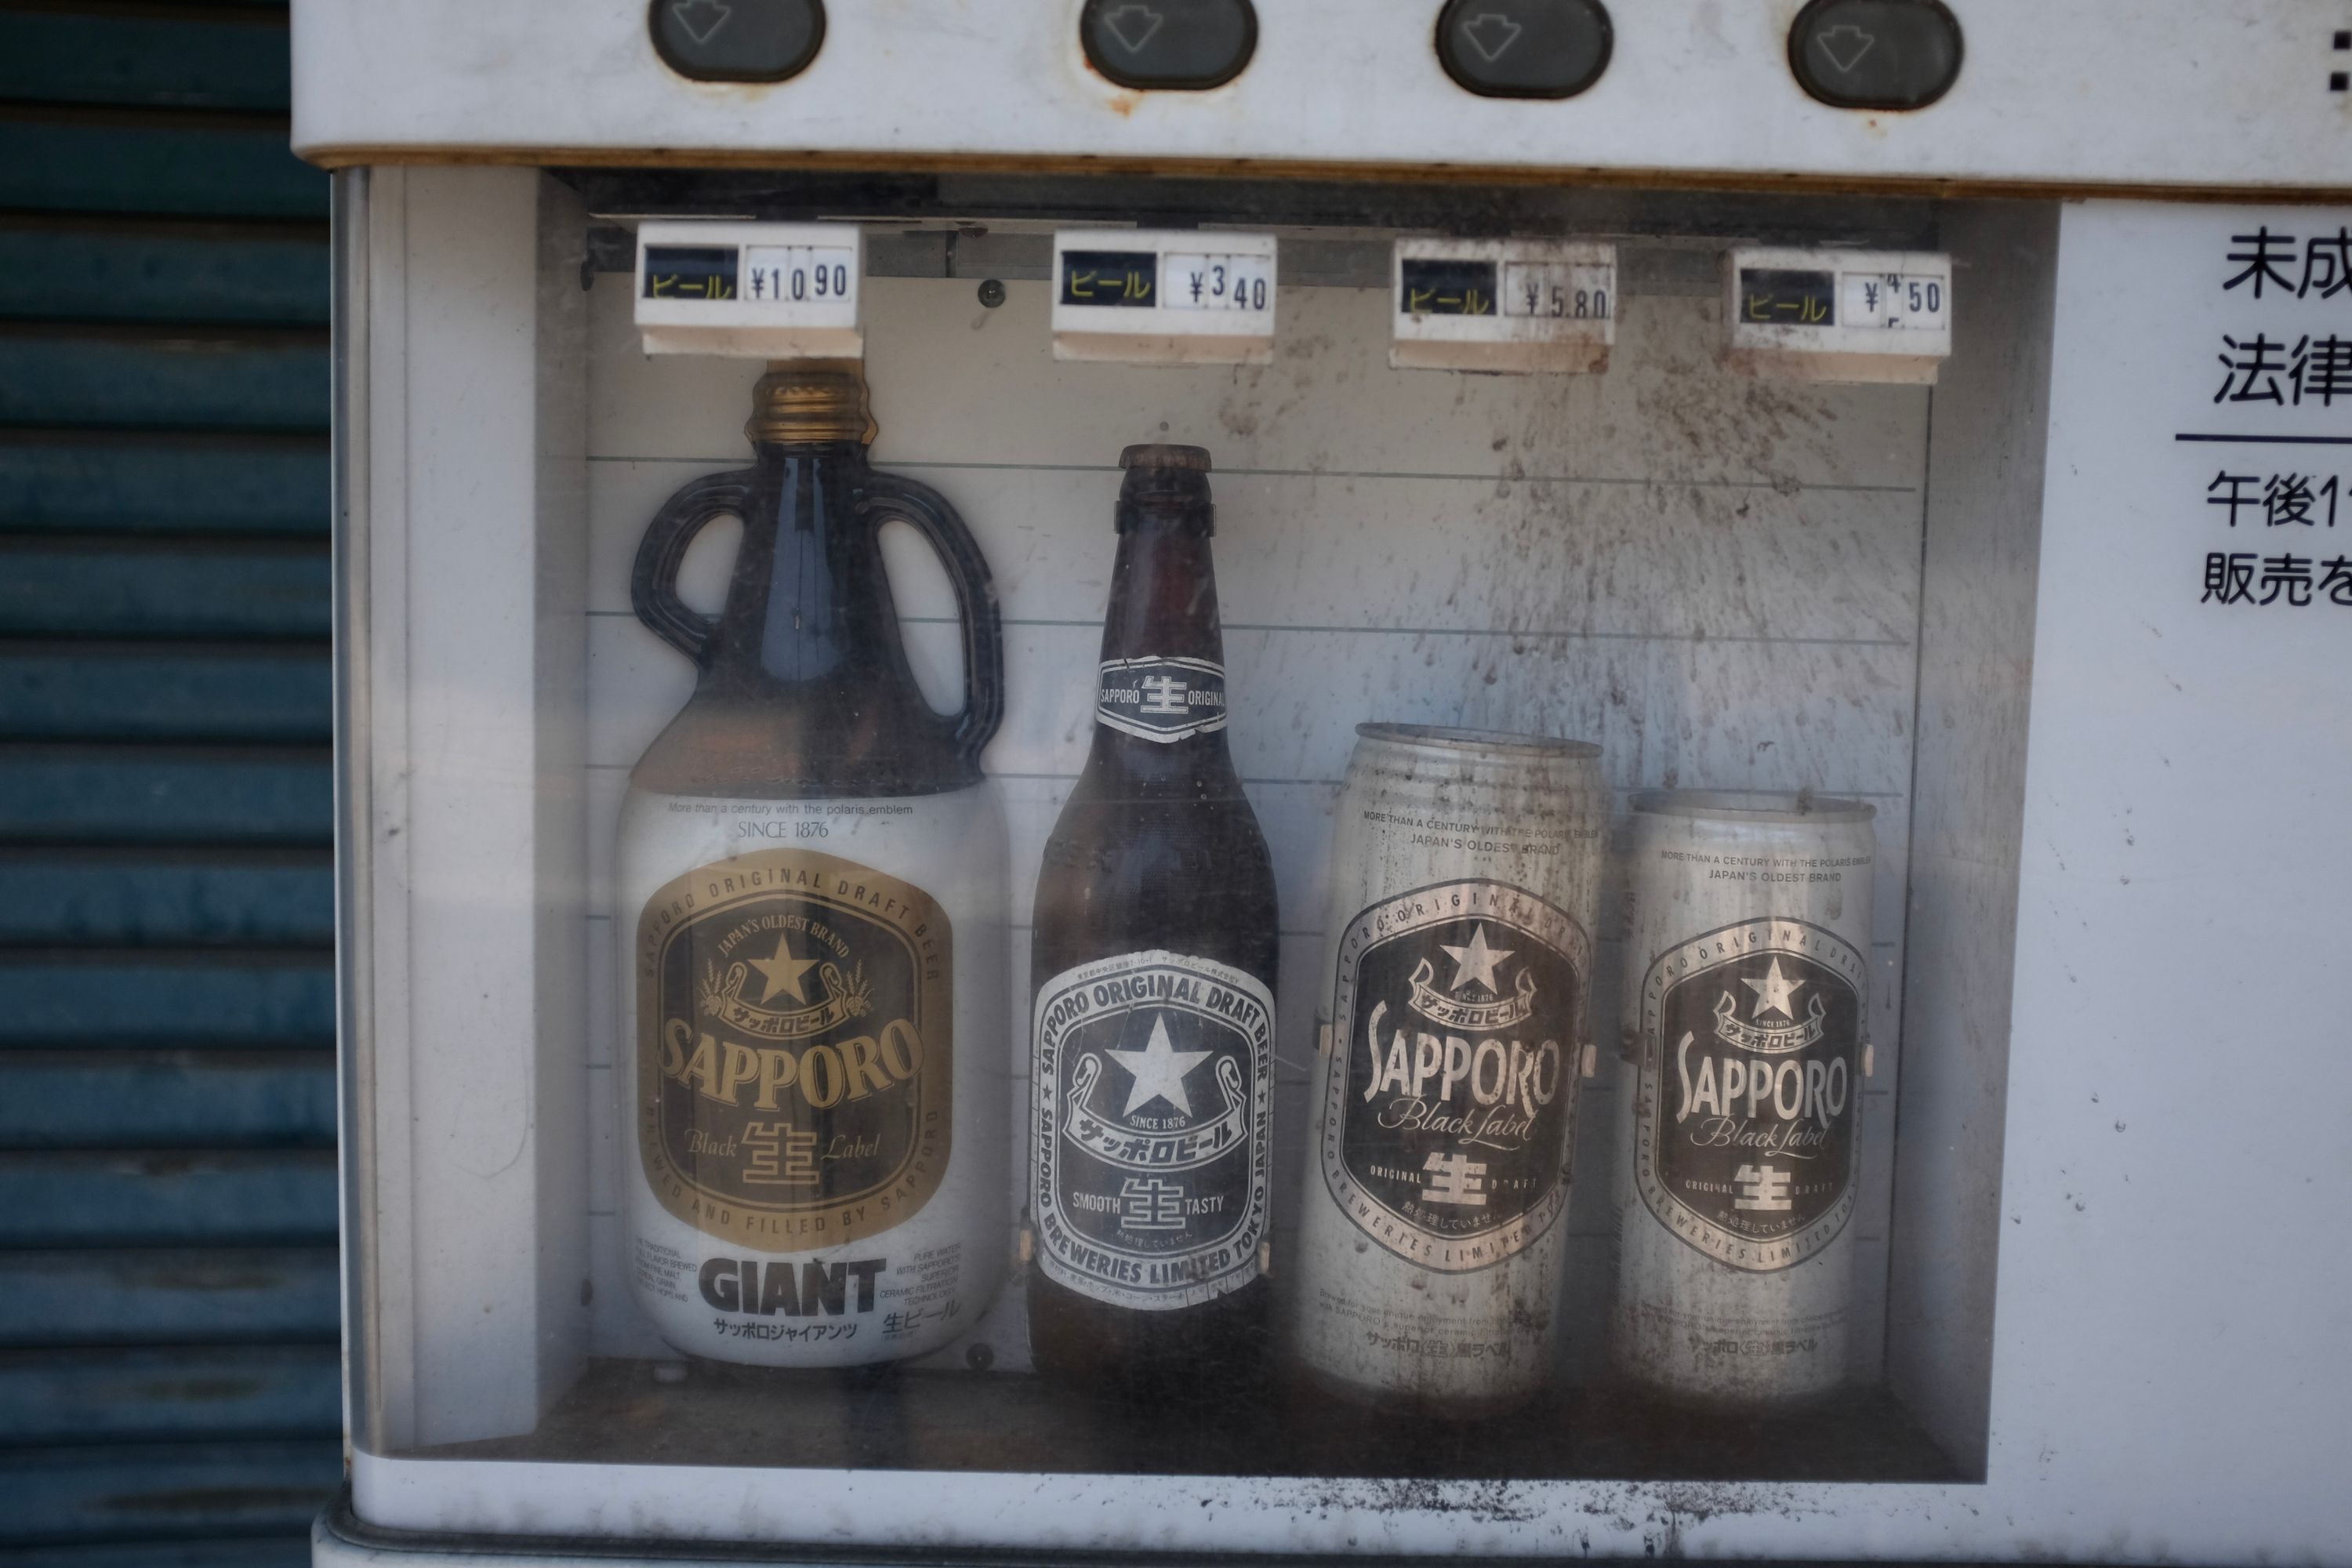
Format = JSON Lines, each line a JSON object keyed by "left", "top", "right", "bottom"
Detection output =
{"left": 294, "top": 0, "right": 2352, "bottom": 188}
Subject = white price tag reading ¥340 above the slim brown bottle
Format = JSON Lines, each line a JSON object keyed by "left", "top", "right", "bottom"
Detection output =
{"left": 1054, "top": 228, "right": 1275, "bottom": 365}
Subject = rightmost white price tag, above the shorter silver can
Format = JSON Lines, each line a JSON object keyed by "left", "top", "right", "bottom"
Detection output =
{"left": 1724, "top": 247, "right": 1952, "bottom": 383}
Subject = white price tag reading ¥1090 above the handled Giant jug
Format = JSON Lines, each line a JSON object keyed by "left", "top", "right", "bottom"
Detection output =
{"left": 637, "top": 223, "right": 866, "bottom": 360}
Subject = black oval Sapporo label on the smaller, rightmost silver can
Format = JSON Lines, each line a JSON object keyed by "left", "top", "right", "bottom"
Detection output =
{"left": 1635, "top": 919, "right": 1870, "bottom": 1274}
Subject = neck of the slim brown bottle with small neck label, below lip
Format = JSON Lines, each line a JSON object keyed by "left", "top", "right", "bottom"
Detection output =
{"left": 1094, "top": 506, "right": 1230, "bottom": 774}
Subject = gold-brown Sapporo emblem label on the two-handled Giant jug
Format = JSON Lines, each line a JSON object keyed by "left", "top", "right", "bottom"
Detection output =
{"left": 635, "top": 848, "right": 955, "bottom": 1253}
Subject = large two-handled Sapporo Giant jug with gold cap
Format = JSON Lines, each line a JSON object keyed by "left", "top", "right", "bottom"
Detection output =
{"left": 614, "top": 362, "right": 1011, "bottom": 1366}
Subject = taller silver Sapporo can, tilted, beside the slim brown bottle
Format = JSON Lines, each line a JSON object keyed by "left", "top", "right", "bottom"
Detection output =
{"left": 1289, "top": 724, "right": 1609, "bottom": 1415}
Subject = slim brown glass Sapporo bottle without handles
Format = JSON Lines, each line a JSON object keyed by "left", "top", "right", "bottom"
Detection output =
{"left": 1028, "top": 447, "right": 1277, "bottom": 1396}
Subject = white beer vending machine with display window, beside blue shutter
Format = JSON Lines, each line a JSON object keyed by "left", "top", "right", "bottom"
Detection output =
{"left": 294, "top": 0, "right": 2352, "bottom": 1566}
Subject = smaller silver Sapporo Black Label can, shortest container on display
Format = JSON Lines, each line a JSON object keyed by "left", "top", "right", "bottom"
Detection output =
{"left": 1609, "top": 789, "right": 1877, "bottom": 1406}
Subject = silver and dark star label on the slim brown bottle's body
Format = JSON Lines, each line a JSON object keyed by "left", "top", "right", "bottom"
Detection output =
{"left": 1030, "top": 952, "right": 1275, "bottom": 1312}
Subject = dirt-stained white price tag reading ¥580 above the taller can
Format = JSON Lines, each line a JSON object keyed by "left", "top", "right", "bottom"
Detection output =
{"left": 1388, "top": 240, "right": 1618, "bottom": 372}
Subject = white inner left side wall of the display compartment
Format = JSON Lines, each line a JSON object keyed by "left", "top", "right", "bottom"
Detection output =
{"left": 369, "top": 169, "right": 586, "bottom": 1441}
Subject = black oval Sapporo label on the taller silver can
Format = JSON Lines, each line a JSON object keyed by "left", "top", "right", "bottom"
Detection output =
{"left": 1319, "top": 879, "right": 1592, "bottom": 1274}
